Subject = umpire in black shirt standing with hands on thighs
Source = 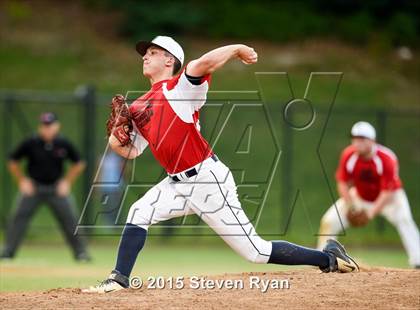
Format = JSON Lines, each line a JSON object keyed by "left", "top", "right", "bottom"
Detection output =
{"left": 0, "top": 112, "right": 90, "bottom": 261}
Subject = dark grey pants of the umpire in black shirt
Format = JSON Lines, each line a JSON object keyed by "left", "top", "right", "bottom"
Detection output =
{"left": 4, "top": 184, "right": 86, "bottom": 257}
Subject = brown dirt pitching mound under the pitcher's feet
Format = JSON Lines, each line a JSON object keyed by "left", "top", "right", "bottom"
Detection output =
{"left": 0, "top": 267, "right": 420, "bottom": 309}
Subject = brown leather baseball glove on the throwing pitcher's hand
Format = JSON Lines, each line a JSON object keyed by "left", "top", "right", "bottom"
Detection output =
{"left": 106, "top": 95, "right": 133, "bottom": 146}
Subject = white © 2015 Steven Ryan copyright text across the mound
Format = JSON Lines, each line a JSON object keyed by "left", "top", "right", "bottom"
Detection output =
{"left": 130, "top": 276, "right": 290, "bottom": 293}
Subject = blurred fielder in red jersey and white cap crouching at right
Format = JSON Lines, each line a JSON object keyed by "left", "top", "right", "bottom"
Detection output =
{"left": 318, "top": 122, "right": 420, "bottom": 268}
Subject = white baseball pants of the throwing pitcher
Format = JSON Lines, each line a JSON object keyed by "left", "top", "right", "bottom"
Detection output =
{"left": 127, "top": 158, "right": 272, "bottom": 264}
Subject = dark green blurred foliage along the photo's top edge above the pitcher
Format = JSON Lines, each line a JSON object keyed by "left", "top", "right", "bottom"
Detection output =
{"left": 85, "top": 0, "right": 420, "bottom": 46}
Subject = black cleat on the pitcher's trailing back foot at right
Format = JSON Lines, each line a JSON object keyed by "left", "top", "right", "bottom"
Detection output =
{"left": 321, "top": 239, "right": 359, "bottom": 272}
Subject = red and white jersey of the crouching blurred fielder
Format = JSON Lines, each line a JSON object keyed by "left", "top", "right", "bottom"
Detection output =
{"left": 336, "top": 144, "right": 402, "bottom": 201}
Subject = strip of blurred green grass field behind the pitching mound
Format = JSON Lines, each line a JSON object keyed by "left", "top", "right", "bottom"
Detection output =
{"left": 0, "top": 239, "right": 408, "bottom": 292}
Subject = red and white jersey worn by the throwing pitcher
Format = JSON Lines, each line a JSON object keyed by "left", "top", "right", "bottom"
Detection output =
{"left": 130, "top": 68, "right": 213, "bottom": 174}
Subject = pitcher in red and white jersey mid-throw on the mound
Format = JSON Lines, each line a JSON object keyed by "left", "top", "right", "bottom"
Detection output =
{"left": 84, "top": 36, "right": 358, "bottom": 293}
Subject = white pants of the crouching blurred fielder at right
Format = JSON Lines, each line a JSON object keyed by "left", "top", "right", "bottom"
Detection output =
{"left": 318, "top": 187, "right": 420, "bottom": 266}
